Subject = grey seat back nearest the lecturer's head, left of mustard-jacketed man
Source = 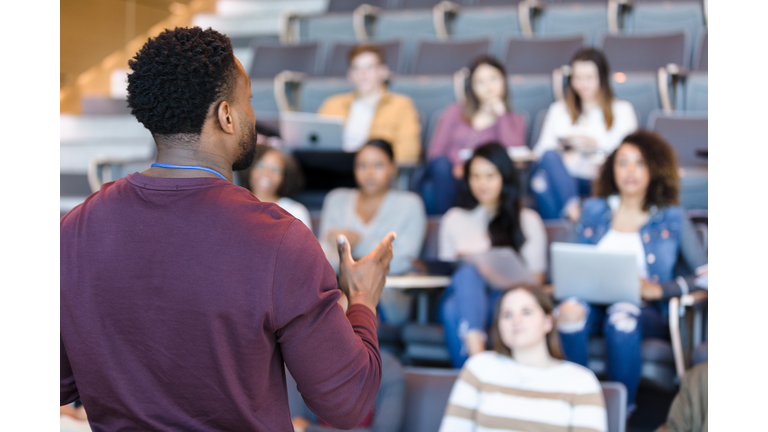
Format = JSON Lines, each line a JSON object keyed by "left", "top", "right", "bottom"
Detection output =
{"left": 248, "top": 42, "right": 318, "bottom": 78}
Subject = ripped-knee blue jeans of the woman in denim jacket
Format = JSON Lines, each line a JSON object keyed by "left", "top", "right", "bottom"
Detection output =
{"left": 559, "top": 300, "right": 669, "bottom": 406}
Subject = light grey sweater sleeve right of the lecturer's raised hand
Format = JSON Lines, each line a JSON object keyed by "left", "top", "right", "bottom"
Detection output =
{"left": 388, "top": 194, "right": 427, "bottom": 274}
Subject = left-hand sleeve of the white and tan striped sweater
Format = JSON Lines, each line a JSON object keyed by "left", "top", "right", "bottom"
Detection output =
{"left": 439, "top": 363, "right": 480, "bottom": 432}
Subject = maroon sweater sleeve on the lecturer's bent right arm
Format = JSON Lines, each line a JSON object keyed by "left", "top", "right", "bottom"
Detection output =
{"left": 271, "top": 220, "right": 381, "bottom": 429}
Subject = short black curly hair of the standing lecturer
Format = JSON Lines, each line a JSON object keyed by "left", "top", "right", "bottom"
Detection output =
{"left": 128, "top": 27, "right": 236, "bottom": 135}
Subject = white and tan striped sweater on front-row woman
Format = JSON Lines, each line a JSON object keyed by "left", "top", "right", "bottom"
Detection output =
{"left": 440, "top": 351, "right": 608, "bottom": 432}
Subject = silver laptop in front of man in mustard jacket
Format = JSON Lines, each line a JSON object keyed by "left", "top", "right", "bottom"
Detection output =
{"left": 280, "top": 112, "right": 344, "bottom": 151}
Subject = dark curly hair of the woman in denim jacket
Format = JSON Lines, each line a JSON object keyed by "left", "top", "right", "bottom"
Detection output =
{"left": 594, "top": 129, "right": 680, "bottom": 210}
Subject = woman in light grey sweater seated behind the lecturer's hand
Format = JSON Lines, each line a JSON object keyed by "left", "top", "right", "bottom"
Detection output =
{"left": 319, "top": 140, "right": 427, "bottom": 325}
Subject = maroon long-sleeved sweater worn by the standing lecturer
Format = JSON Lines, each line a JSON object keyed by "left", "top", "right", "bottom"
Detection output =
{"left": 60, "top": 173, "right": 381, "bottom": 432}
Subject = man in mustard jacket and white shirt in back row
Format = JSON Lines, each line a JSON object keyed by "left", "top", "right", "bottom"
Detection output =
{"left": 317, "top": 45, "right": 421, "bottom": 163}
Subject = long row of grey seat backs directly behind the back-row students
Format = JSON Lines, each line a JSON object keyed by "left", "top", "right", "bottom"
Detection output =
{"left": 235, "top": 32, "right": 708, "bottom": 79}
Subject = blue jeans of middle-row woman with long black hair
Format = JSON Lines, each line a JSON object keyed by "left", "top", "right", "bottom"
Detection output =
{"left": 440, "top": 264, "right": 501, "bottom": 368}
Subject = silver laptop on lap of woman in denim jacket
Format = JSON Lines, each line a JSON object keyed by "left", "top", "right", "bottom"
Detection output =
{"left": 550, "top": 242, "right": 640, "bottom": 305}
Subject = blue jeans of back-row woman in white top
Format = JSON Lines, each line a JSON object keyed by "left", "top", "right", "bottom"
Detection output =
{"left": 529, "top": 151, "right": 591, "bottom": 219}
